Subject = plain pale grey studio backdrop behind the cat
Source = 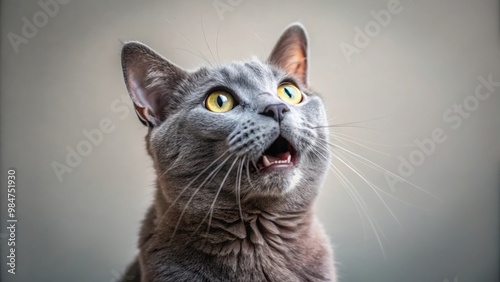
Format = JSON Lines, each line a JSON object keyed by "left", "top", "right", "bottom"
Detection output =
{"left": 0, "top": 0, "right": 500, "bottom": 282}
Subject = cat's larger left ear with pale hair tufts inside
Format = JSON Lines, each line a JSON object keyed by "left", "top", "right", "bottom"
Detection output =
{"left": 122, "top": 42, "right": 187, "bottom": 127}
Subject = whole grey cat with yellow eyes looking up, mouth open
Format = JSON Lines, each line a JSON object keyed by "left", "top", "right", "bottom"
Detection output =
{"left": 122, "top": 24, "right": 336, "bottom": 282}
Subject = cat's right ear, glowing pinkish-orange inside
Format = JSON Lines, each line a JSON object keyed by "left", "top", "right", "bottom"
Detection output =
{"left": 268, "top": 23, "right": 307, "bottom": 85}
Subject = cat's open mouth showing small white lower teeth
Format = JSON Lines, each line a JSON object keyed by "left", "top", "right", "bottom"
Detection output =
{"left": 258, "top": 135, "right": 297, "bottom": 170}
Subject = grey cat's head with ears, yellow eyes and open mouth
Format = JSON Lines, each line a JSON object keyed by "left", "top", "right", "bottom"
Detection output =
{"left": 122, "top": 24, "right": 329, "bottom": 213}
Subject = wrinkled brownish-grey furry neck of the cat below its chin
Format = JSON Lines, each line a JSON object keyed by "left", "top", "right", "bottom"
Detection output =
{"left": 155, "top": 189, "right": 313, "bottom": 256}
